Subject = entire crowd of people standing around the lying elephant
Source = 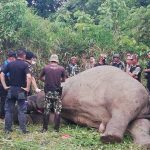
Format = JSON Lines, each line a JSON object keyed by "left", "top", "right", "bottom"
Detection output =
{"left": 0, "top": 50, "right": 150, "bottom": 134}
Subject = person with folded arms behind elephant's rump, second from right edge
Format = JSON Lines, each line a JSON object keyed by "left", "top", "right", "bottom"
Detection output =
{"left": 129, "top": 54, "right": 142, "bottom": 82}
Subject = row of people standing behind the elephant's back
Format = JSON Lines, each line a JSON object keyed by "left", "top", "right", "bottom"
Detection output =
{"left": 66, "top": 52, "right": 150, "bottom": 91}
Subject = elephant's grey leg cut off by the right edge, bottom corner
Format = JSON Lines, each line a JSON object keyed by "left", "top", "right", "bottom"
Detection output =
{"left": 129, "top": 119, "right": 150, "bottom": 148}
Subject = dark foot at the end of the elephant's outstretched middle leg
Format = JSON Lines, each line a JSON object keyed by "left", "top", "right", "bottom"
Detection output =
{"left": 101, "top": 135, "right": 122, "bottom": 144}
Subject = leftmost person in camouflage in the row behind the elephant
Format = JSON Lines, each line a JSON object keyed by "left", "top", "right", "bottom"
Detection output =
{"left": 66, "top": 56, "right": 80, "bottom": 77}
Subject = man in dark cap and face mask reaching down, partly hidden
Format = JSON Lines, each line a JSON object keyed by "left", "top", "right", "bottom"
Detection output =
{"left": 26, "top": 51, "right": 41, "bottom": 95}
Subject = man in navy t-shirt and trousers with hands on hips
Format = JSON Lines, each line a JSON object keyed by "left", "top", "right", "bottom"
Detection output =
{"left": 1, "top": 50, "right": 31, "bottom": 134}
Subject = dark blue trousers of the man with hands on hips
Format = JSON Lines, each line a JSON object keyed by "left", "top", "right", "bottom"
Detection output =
{"left": 5, "top": 88, "right": 26, "bottom": 131}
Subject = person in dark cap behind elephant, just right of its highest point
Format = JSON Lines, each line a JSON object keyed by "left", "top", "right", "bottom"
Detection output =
{"left": 111, "top": 54, "right": 125, "bottom": 71}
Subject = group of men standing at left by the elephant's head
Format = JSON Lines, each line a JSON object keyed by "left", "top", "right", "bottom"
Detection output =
{"left": 0, "top": 50, "right": 65, "bottom": 134}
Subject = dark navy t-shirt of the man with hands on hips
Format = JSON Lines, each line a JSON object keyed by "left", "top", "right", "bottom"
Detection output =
{"left": 3, "top": 59, "right": 30, "bottom": 87}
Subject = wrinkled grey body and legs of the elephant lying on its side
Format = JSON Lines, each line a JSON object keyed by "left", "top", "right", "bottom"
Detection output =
{"left": 27, "top": 66, "right": 150, "bottom": 146}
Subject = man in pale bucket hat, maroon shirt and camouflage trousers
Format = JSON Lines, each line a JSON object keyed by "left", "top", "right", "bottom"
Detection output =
{"left": 40, "top": 54, "right": 65, "bottom": 132}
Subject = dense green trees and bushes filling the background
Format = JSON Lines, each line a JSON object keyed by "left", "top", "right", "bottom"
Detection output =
{"left": 0, "top": 0, "right": 150, "bottom": 61}
